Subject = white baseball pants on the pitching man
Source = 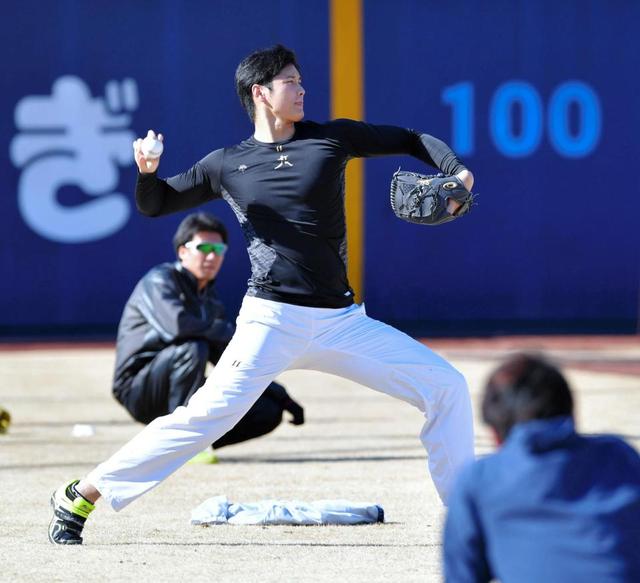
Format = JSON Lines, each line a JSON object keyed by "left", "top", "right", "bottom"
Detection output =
{"left": 87, "top": 296, "right": 473, "bottom": 510}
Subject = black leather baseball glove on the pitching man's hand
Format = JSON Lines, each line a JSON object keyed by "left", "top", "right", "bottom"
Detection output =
{"left": 391, "top": 169, "right": 475, "bottom": 226}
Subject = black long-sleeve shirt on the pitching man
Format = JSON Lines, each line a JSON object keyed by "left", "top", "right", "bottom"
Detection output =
{"left": 136, "top": 120, "right": 465, "bottom": 308}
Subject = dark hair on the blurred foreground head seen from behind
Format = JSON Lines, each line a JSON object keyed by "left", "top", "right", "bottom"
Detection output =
{"left": 482, "top": 354, "right": 573, "bottom": 441}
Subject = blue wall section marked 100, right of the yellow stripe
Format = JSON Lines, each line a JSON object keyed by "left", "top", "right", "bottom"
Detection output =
{"left": 365, "top": 0, "right": 640, "bottom": 332}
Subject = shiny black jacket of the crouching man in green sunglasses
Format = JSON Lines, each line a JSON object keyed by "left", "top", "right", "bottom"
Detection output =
{"left": 113, "top": 262, "right": 235, "bottom": 395}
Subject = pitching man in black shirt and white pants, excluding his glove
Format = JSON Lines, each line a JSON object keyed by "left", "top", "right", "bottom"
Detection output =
{"left": 49, "top": 45, "right": 473, "bottom": 544}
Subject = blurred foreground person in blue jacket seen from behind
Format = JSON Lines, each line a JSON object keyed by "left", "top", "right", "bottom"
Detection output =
{"left": 444, "top": 354, "right": 640, "bottom": 583}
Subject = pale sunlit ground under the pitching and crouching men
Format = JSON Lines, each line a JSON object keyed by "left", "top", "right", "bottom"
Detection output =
{"left": 0, "top": 337, "right": 640, "bottom": 583}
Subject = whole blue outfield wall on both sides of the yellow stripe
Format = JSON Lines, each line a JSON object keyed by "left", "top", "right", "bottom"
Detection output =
{"left": 0, "top": 0, "right": 640, "bottom": 336}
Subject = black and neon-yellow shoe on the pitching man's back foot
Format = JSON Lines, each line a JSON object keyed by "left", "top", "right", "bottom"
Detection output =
{"left": 49, "top": 480, "right": 95, "bottom": 545}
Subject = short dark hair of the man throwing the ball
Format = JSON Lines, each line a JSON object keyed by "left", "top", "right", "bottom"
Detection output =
{"left": 236, "top": 45, "right": 300, "bottom": 121}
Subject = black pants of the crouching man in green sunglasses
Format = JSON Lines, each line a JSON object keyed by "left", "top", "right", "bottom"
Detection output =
{"left": 117, "top": 341, "right": 284, "bottom": 449}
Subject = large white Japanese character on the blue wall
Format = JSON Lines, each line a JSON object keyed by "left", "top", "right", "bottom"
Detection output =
{"left": 10, "top": 76, "right": 138, "bottom": 243}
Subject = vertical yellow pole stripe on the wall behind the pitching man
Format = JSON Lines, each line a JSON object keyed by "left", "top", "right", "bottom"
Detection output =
{"left": 330, "top": 0, "right": 364, "bottom": 302}
